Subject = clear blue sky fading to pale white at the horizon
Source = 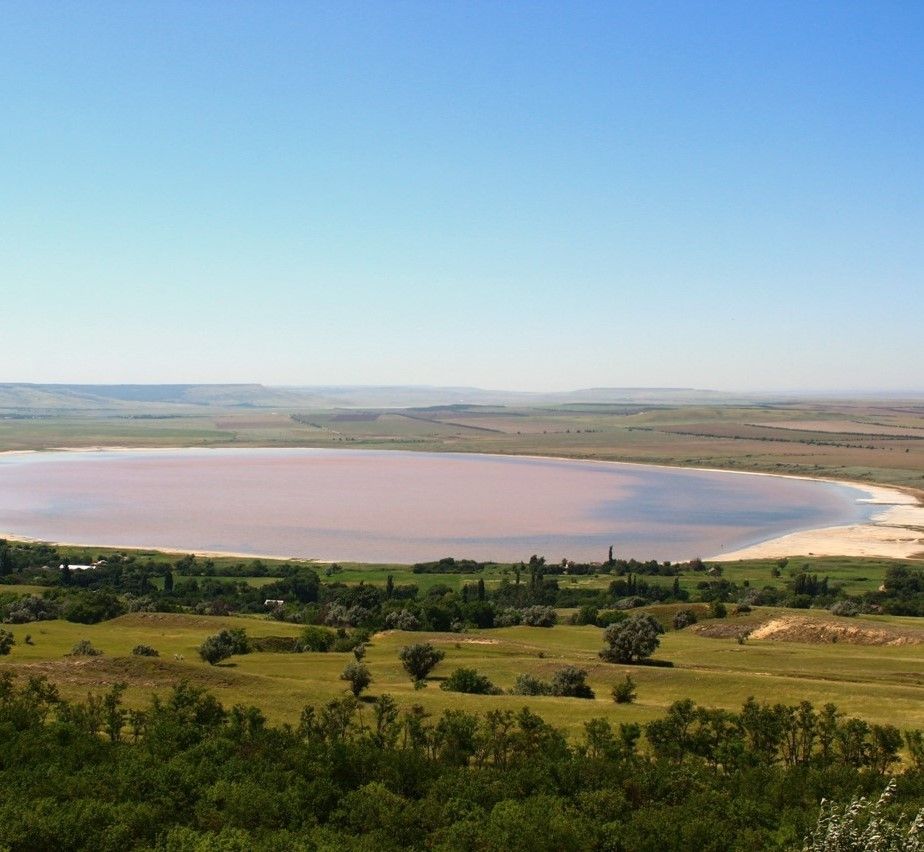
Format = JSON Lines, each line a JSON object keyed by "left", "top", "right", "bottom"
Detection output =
{"left": 0, "top": 0, "right": 924, "bottom": 389}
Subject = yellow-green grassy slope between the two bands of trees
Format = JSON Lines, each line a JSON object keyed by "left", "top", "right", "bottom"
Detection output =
{"left": 0, "top": 607, "right": 924, "bottom": 735}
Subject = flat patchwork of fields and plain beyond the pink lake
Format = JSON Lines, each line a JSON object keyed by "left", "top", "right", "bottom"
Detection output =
{"left": 0, "top": 400, "right": 924, "bottom": 489}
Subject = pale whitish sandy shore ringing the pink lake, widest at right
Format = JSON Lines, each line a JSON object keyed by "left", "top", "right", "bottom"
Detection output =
{"left": 0, "top": 445, "right": 924, "bottom": 565}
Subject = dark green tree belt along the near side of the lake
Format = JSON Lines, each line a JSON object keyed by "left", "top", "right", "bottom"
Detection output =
{"left": 0, "top": 540, "right": 924, "bottom": 628}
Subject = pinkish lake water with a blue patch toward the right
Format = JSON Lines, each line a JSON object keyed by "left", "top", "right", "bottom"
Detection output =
{"left": 0, "top": 449, "right": 871, "bottom": 562}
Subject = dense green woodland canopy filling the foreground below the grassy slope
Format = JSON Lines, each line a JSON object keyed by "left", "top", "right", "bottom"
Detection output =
{"left": 0, "top": 674, "right": 924, "bottom": 852}
